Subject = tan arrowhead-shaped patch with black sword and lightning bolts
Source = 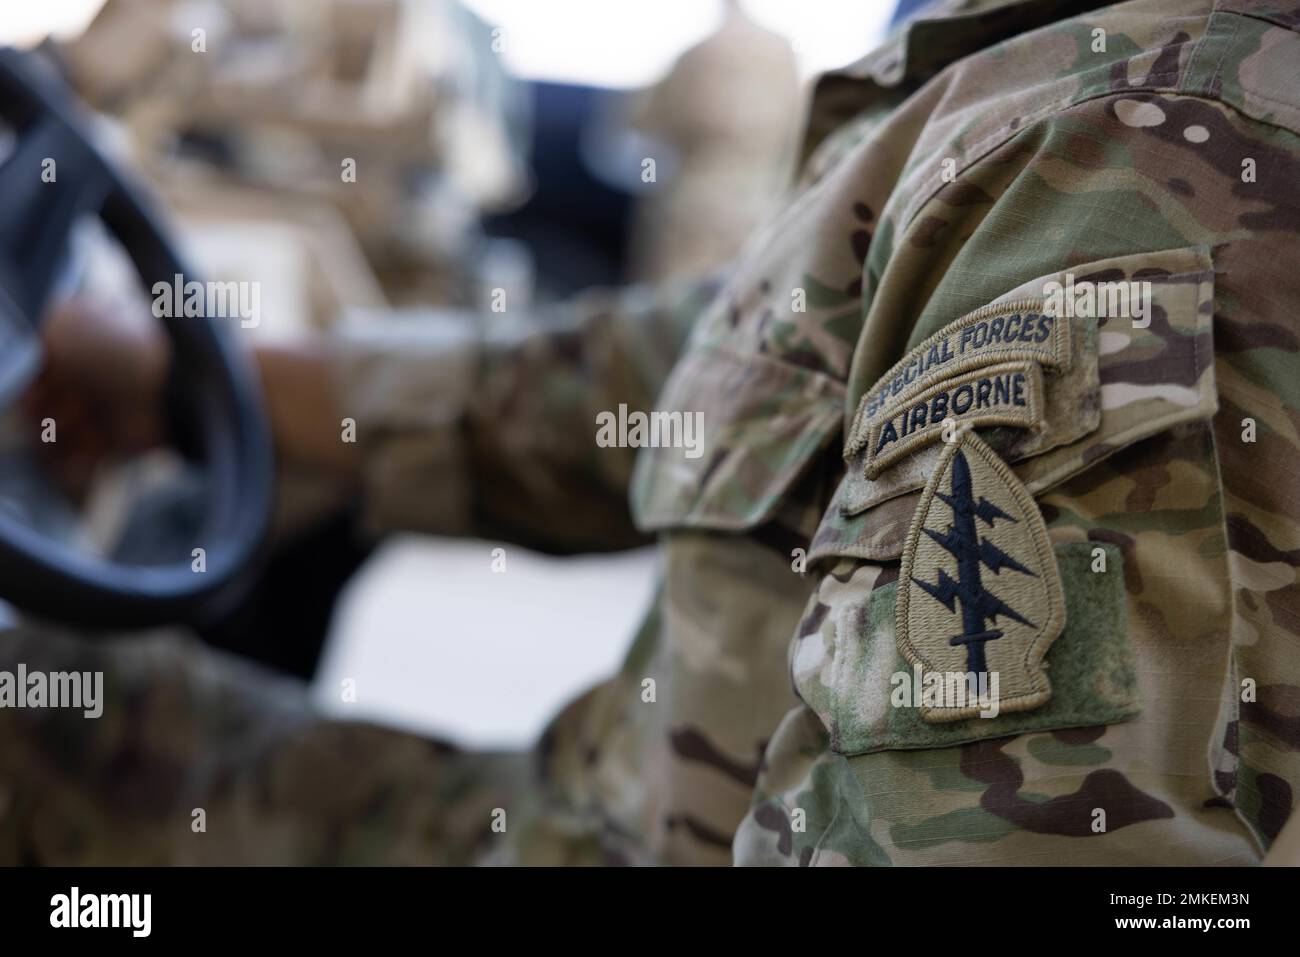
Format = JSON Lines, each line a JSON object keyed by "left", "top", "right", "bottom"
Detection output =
{"left": 896, "top": 428, "right": 1065, "bottom": 722}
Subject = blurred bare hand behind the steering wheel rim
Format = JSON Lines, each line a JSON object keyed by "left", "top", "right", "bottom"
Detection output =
{"left": 21, "top": 299, "right": 170, "bottom": 499}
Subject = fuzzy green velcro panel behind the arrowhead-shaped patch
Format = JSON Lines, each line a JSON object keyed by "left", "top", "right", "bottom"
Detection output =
{"left": 831, "top": 542, "right": 1141, "bottom": 754}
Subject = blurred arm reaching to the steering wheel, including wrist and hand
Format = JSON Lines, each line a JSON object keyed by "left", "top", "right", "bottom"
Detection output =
{"left": 27, "top": 273, "right": 715, "bottom": 553}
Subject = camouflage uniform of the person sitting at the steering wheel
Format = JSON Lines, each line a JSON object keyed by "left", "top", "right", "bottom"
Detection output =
{"left": 0, "top": 0, "right": 1300, "bottom": 865}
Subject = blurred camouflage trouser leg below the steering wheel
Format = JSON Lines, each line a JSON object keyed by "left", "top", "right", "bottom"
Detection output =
{"left": 0, "top": 623, "right": 530, "bottom": 865}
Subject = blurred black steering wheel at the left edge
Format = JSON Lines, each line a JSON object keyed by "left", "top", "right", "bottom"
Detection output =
{"left": 0, "top": 48, "right": 273, "bottom": 629}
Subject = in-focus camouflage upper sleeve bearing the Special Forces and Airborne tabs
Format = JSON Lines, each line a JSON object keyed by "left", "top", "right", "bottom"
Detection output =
{"left": 735, "top": 78, "right": 1300, "bottom": 866}
